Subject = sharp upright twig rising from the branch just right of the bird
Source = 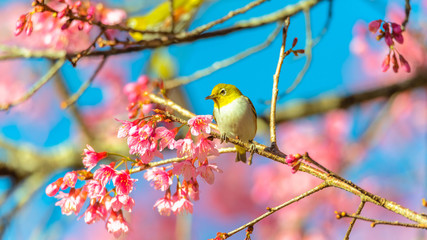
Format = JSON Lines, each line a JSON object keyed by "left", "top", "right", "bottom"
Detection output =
{"left": 270, "top": 17, "right": 290, "bottom": 144}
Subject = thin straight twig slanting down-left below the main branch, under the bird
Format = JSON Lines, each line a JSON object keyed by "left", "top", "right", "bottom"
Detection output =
{"left": 226, "top": 182, "right": 329, "bottom": 238}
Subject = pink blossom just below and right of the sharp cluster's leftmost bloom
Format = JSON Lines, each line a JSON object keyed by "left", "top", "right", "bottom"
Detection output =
{"left": 55, "top": 188, "right": 86, "bottom": 215}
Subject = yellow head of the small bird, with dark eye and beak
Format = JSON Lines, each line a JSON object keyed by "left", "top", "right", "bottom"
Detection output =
{"left": 205, "top": 83, "right": 242, "bottom": 108}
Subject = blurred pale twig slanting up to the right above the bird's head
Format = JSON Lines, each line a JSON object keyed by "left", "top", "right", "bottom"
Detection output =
{"left": 165, "top": 24, "right": 282, "bottom": 89}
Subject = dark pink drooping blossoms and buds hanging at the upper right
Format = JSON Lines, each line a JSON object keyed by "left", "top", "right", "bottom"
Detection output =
{"left": 369, "top": 20, "right": 411, "bottom": 72}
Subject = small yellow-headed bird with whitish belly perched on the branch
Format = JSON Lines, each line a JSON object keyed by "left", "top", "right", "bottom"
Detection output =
{"left": 205, "top": 83, "right": 257, "bottom": 163}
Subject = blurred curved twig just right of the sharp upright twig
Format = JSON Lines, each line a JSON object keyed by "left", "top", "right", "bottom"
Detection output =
{"left": 286, "top": 9, "right": 313, "bottom": 94}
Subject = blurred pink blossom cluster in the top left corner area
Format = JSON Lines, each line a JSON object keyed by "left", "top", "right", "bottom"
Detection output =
{"left": 15, "top": 0, "right": 126, "bottom": 51}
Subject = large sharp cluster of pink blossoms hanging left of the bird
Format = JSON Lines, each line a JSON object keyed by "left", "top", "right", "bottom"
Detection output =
{"left": 46, "top": 109, "right": 221, "bottom": 237}
